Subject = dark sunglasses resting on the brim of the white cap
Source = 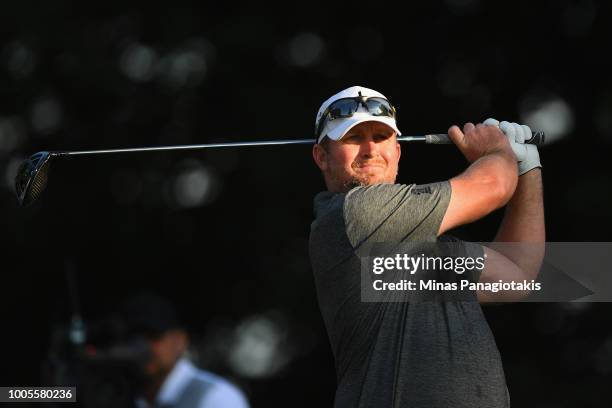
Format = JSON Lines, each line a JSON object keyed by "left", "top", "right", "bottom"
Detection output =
{"left": 315, "top": 95, "right": 396, "bottom": 140}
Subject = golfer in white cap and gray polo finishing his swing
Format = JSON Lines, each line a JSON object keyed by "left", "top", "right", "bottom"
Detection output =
{"left": 310, "top": 86, "right": 544, "bottom": 408}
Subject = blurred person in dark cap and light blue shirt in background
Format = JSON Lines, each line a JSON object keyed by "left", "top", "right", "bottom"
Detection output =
{"left": 121, "top": 292, "right": 249, "bottom": 408}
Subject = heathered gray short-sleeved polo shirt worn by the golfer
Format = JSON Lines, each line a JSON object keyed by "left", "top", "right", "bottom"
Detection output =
{"left": 310, "top": 182, "right": 509, "bottom": 408}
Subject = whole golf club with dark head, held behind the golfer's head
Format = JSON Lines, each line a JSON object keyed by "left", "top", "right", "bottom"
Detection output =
{"left": 15, "top": 132, "right": 545, "bottom": 206}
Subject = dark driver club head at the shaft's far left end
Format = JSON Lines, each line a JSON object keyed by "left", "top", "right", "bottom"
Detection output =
{"left": 15, "top": 152, "right": 54, "bottom": 207}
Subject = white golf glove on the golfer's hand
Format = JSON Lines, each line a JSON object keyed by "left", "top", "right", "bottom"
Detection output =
{"left": 482, "top": 118, "right": 542, "bottom": 176}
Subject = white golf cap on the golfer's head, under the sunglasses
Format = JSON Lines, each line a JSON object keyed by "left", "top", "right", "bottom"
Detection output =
{"left": 315, "top": 86, "right": 402, "bottom": 143}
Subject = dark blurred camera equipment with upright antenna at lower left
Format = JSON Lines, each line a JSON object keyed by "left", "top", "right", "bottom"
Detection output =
{"left": 41, "top": 263, "right": 150, "bottom": 408}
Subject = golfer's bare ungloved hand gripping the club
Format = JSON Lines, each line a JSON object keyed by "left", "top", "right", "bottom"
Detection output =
{"left": 448, "top": 123, "right": 511, "bottom": 163}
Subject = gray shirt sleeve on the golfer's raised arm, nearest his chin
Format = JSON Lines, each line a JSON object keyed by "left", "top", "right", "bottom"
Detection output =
{"left": 343, "top": 181, "right": 451, "bottom": 249}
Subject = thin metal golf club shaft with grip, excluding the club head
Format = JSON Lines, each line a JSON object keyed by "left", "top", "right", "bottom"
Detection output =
{"left": 54, "top": 132, "right": 544, "bottom": 156}
